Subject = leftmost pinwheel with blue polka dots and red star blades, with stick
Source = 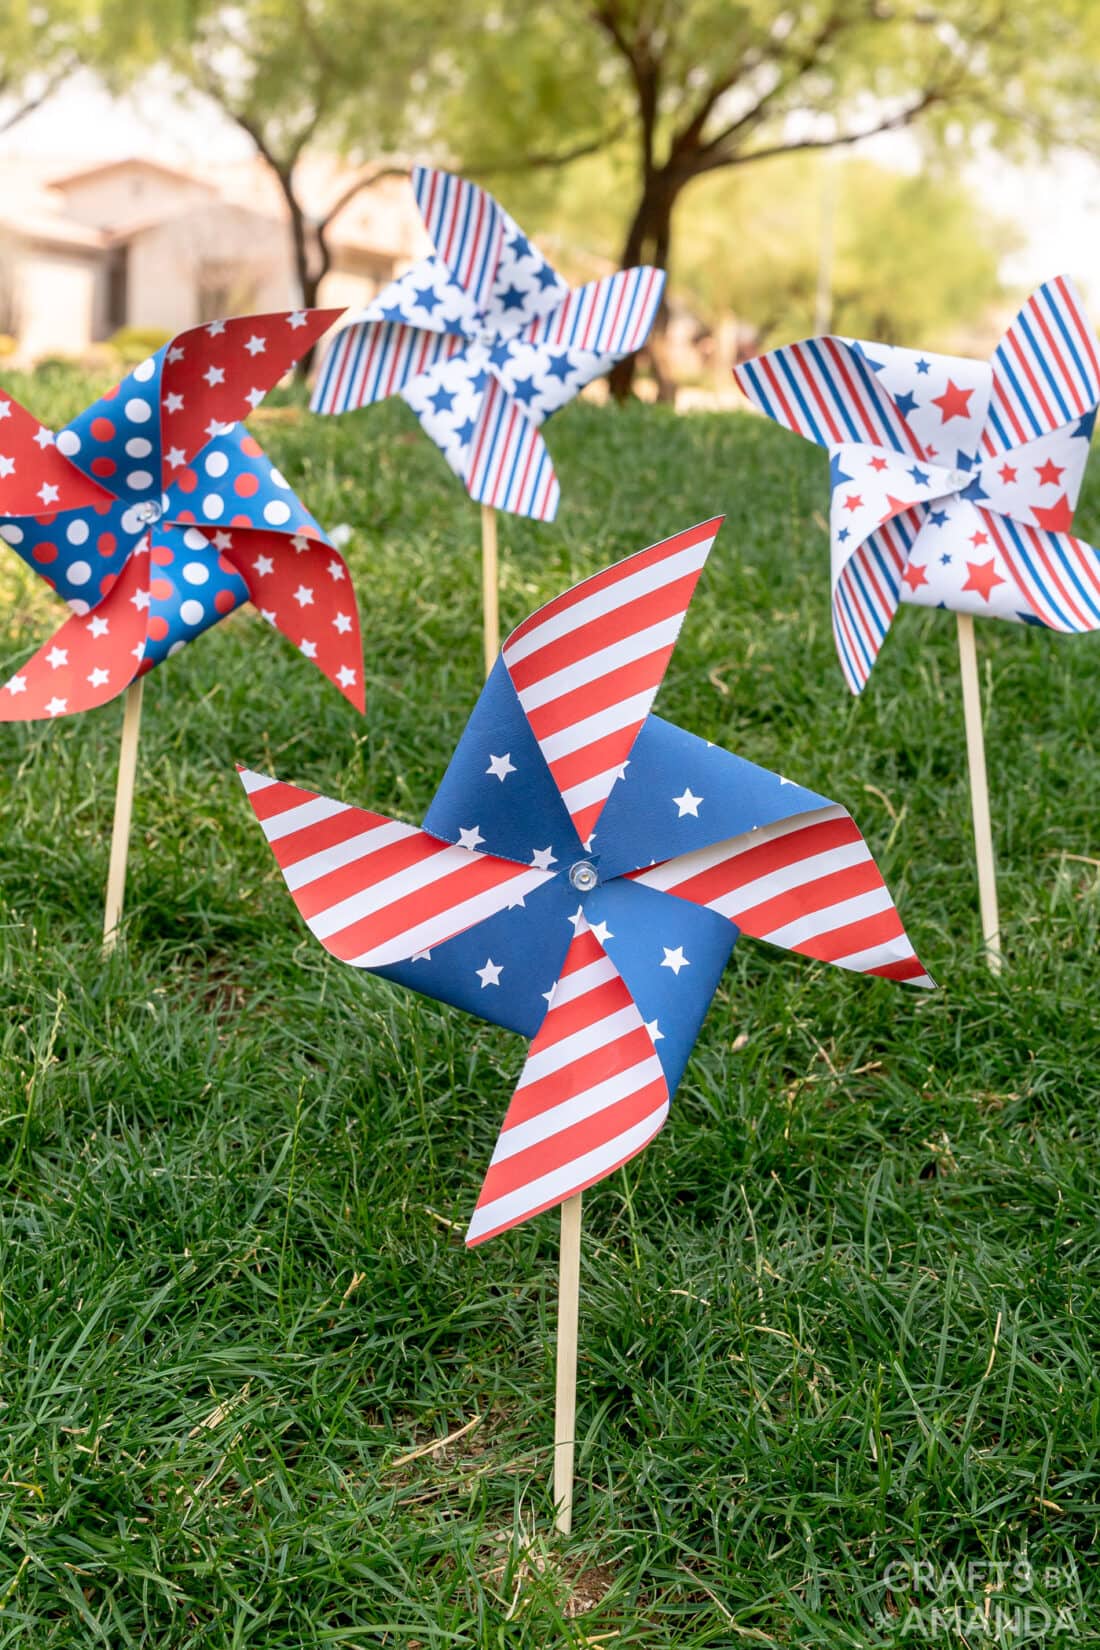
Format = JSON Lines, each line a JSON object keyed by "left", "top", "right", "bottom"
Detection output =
{"left": 0, "top": 310, "right": 363, "bottom": 945}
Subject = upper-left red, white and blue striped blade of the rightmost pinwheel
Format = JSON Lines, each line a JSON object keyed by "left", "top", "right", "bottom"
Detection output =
{"left": 734, "top": 337, "right": 925, "bottom": 459}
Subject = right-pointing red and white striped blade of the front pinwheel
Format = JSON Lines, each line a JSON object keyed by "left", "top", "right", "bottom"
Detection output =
{"left": 635, "top": 805, "right": 935, "bottom": 987}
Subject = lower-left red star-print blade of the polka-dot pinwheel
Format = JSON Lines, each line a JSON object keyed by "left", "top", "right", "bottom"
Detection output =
{"left": 0, "top": 545, "right": 150, "bottom": 721}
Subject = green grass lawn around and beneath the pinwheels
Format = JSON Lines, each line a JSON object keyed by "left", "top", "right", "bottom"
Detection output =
{"left": 0, "top": 376, "right": 1100, "bottom": 1650}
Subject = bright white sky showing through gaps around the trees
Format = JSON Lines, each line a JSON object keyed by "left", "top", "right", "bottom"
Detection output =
{"left": 0, "top": 73, "right": 1100, "bottom": 309}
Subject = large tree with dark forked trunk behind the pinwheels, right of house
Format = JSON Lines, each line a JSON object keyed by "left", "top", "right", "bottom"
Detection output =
{"left": 451, "top": 0, "right": 1100, "bottom": 394}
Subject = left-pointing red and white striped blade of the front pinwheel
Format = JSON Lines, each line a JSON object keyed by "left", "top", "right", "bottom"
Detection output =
{"left": 239, "top": 769, "right": 554, "bottom": 969}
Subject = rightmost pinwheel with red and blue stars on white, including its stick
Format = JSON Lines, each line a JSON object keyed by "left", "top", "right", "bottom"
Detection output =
{"left": 734, "top": 276, "right": 1100, "bottom": 970}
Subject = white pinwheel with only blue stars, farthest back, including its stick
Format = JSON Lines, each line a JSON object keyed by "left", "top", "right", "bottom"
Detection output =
{"left": 312, "top": 167, "right": 665, "bottom": 675}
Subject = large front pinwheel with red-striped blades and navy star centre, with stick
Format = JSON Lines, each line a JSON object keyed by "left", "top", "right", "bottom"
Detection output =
{"left": 241, "top": 521, "right": 932, "bottom": 1530}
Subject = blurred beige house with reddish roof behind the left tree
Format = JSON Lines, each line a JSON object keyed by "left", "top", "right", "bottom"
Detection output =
{"left": 0, "top": 157, "right": 424, "bottom": 363}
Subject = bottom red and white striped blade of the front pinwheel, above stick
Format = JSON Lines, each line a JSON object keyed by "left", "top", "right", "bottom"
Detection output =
{"left": 467, "top": 919, "right": 668, "bottom": 1246}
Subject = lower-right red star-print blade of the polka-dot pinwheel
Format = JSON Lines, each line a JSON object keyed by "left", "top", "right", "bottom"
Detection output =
{"left": 224, "top": 528, "right": 364, "bottom": 711}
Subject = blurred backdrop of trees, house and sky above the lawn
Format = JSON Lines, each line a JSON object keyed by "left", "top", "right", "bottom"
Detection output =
{"left": 0, "top": 0, "right": 1100, "bottom": 399}
